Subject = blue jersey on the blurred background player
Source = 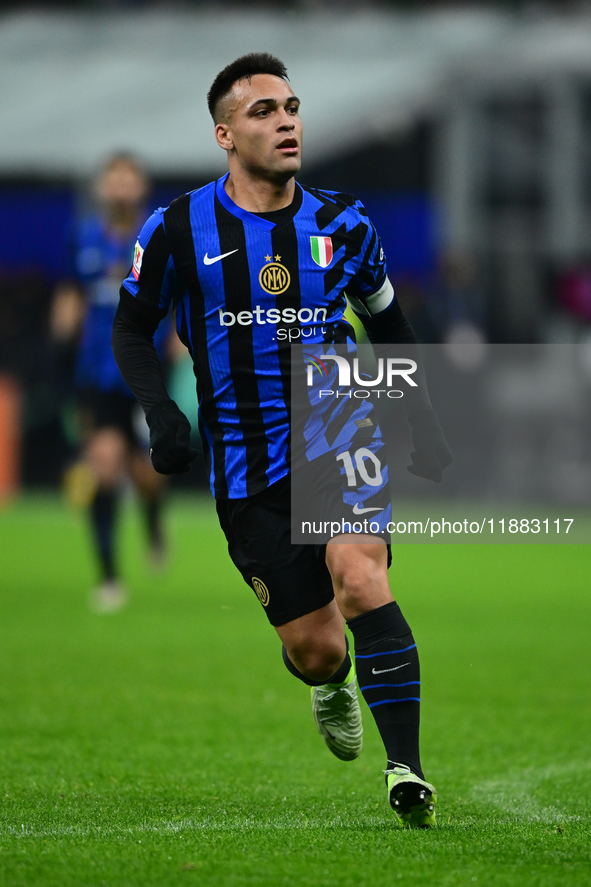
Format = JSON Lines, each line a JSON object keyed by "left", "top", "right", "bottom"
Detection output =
{"left": 69, "top": 214, "right": 168, "bottom": 398}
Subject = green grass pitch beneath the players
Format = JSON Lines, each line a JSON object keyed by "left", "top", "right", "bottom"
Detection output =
{"left": 0, "top": 498, "right": 591, "bottom": 887}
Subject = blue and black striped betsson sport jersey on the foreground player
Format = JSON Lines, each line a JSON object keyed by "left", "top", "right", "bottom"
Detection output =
{"left": 115, "top": 176, "right": 416, "bottom": 498}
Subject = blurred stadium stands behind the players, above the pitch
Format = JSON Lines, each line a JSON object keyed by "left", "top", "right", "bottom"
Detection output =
{"left": 0, "top": 2, "right": 591, "bottom": 485}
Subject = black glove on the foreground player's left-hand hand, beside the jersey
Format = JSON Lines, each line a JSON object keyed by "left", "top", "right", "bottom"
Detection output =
{"left": 146, "top": 400, "right": 197, "bottom": 474}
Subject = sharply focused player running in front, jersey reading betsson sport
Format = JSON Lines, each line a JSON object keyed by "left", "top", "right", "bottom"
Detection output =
{"left": 113, "top": 53, "right": 451, "bottom": 827}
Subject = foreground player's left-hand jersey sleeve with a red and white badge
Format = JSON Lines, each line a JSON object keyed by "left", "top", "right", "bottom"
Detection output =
{"left": 118, "top": 210, "right": 180, "bottom": 314}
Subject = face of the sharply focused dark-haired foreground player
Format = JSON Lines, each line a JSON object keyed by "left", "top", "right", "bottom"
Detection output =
{"left": 216, "top": 74, "right": 302, "bottom": 182}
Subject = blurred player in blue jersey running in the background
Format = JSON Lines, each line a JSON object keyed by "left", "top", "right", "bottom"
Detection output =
{"left": 50, "top": 153, "right": 168, "bottom": 612}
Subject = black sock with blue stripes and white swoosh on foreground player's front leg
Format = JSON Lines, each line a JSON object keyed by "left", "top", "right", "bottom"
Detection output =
{"left": 347, "top": 601, "right": 424, "bottom": 779}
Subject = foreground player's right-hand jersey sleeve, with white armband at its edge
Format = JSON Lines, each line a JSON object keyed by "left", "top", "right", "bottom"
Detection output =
{"left": 345, "top": 219, "right": 394, "bottom": 318}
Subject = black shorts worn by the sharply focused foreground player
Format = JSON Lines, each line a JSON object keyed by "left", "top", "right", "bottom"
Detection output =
{"left": 216, "top": 476, "right": 334, "bottom": 625}
